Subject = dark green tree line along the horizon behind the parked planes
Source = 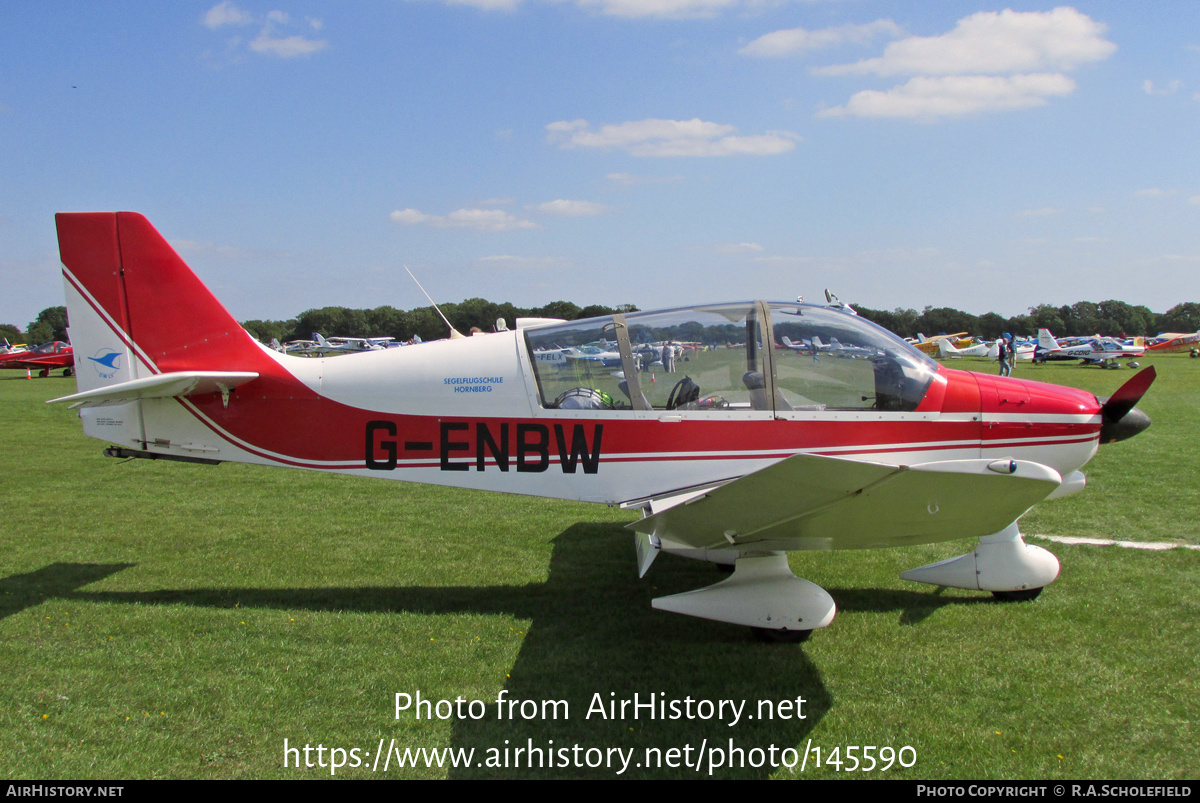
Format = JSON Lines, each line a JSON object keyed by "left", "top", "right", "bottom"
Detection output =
{"left": 0, "top": 299, "right": 1200, "bottom": 344}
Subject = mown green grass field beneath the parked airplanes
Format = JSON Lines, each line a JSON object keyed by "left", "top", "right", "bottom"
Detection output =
{"left": 0, "top": 356, "right": 1200, "bottom": 779}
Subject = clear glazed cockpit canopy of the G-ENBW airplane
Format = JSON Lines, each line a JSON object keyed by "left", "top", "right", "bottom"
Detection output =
{"left": 524, "top": 301, "right": 937, "bottom": 415}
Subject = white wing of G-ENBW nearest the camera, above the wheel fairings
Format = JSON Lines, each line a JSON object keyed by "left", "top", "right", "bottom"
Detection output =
{"left": 629, "top": 455, "right": 1062, "bottom": 550}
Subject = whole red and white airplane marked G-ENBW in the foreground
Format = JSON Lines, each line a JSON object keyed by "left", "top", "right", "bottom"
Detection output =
{"left": 55, "top": 212, "right": 1154, "bottom": 641}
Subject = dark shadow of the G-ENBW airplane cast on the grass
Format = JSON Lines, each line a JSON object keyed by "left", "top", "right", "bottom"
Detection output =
{"left": 0, "top": 522, "right": 982, "bottom": 778}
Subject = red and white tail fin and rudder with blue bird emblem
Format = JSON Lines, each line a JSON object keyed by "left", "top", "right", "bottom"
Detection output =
{"left": 55, "top": 212, "right": 288, "bottom": 451}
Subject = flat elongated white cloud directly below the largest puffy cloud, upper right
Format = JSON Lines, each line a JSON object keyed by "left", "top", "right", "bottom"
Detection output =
{"left": 817, "top": 73, "right": 1075, "bottom": 120}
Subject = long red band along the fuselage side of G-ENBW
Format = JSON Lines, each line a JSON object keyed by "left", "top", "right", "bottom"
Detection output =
{"left": 177, "top": 380, "right": 1099, "bottom": 468}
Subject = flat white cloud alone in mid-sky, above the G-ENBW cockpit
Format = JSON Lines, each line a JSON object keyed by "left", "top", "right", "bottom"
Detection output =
{"left": 546, "top": 119, "right": 800, "bottom": 156}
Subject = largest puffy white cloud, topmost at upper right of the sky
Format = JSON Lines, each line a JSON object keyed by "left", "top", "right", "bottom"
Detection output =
{"left": 816, "top": 7, "right": 1117, "bottom": 76}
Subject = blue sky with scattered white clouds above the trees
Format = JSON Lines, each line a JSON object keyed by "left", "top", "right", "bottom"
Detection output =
{"left": 0, "top": 0, "right": 1200, "bottom": 326}
